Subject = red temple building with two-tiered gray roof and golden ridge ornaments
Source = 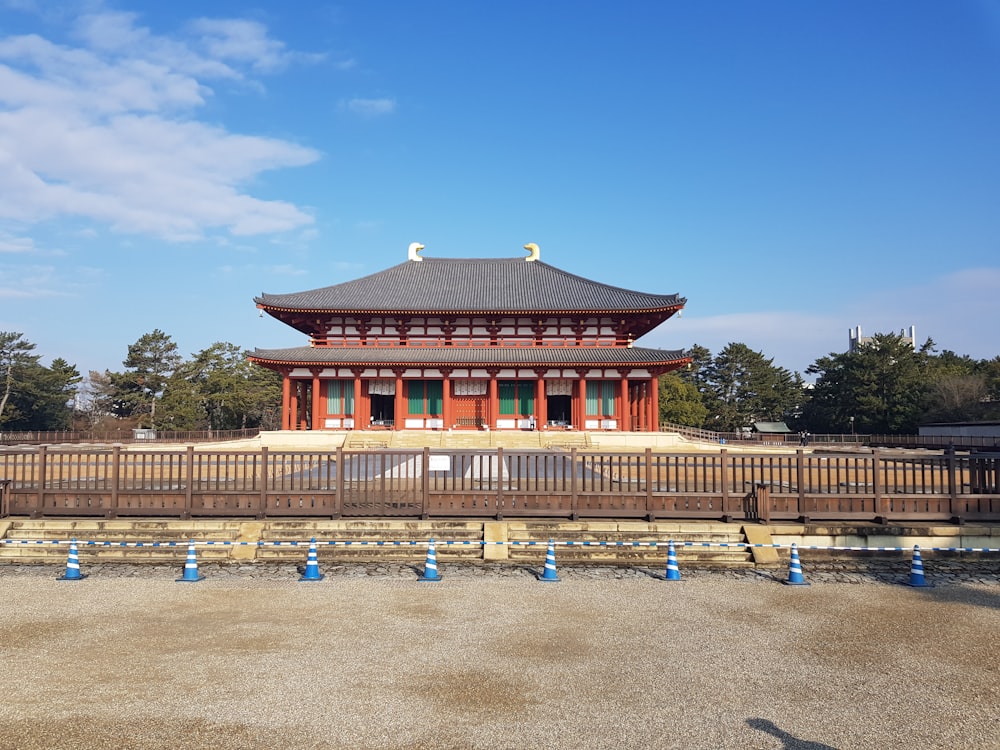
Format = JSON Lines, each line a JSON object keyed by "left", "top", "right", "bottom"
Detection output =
{"left": 250, "top": 243, "right": 690, "bottom": 432}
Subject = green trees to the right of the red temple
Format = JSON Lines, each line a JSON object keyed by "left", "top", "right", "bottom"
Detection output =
{"left": 660, "top": 334, "right": 1000, "bottom": 435}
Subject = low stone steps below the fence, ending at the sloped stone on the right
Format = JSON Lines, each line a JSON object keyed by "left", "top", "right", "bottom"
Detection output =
{"left": 0, "top": 518, "right": 752, "bottom": 575}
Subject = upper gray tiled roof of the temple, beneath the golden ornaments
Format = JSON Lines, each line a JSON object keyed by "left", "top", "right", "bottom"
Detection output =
{"left": 255, "top": 258, "right": 686, "bottom": 313}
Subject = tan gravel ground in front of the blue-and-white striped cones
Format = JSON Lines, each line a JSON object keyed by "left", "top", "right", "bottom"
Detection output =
{"left": 0, "top": 560, "right": 1000, "bottom": 750}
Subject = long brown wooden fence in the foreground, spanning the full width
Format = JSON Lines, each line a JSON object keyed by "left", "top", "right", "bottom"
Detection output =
{"left": 0, "top": 446, "right": 1000, "bottom": 521}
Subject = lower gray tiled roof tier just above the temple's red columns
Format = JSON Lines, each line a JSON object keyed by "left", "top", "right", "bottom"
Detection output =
{"left": 250, "top": 346, "right": 687, "bottom": 367}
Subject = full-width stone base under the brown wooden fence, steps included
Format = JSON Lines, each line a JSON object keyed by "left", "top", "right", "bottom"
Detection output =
{"left": 0, "top": 518, "right": 1000, "bottom": 567}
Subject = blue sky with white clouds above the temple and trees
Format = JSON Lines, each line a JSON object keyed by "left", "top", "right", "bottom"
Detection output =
{"left": 0, "top": 0, "right": 1000, "bottom": 373}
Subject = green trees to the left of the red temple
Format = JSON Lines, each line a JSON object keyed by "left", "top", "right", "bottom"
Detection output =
{"left": 0, "top": 329, "right": 281, "bottom": 431}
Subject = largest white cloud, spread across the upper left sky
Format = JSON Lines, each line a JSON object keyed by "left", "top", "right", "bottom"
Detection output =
{"left": 0, "top": 12, "right": 319, "bottom": 241}
